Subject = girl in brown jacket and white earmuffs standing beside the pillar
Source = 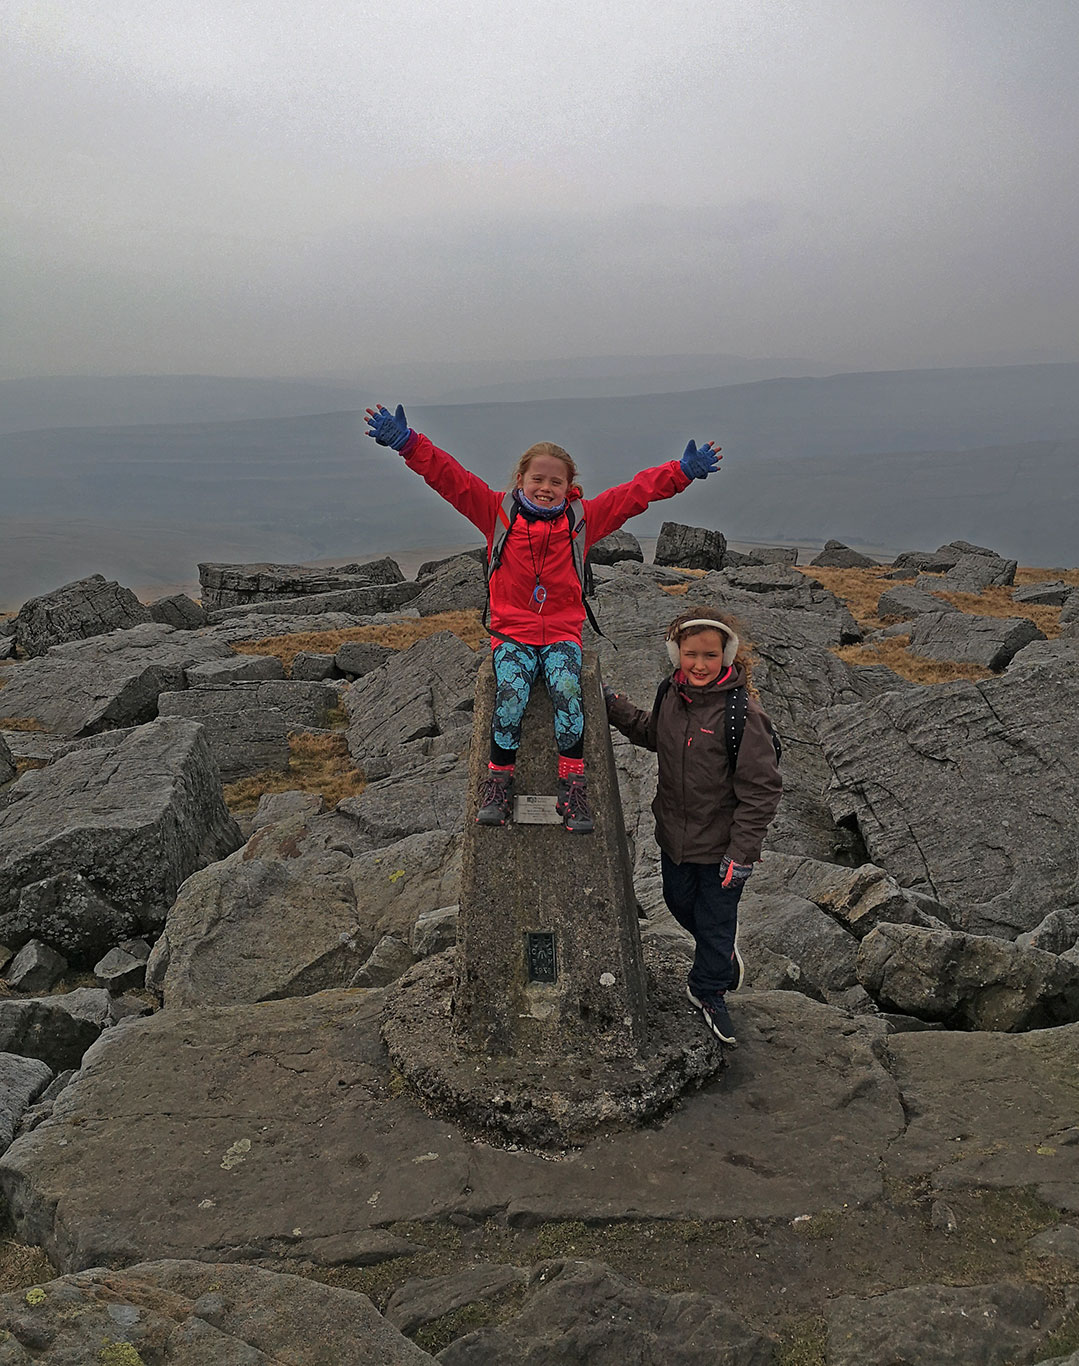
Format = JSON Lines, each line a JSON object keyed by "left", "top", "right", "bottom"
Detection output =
{"left": 604, "top": 608, "right": 783, "bottom": 1044}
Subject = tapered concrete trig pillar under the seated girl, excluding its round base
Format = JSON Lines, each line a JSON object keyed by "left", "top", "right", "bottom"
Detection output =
{"left": 453, "top": 654, "right": 647, "bottom": 1057}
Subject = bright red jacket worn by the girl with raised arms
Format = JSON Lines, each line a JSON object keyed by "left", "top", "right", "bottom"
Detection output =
{"left": 402, "top": 432, "right": 692, "bottom": 646}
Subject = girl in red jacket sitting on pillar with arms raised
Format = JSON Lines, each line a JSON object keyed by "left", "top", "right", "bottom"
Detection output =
{"left": 367, "top": 403, "right": 720, "bottom": 835}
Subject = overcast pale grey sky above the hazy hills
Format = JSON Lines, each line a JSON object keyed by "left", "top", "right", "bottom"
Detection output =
{"left": 0, "top": 0, "right": 1079, "bottom": 376}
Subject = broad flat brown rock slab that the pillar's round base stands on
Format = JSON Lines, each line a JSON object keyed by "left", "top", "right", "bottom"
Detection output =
{"left": 0, "top": 990, "right": 906, "bottom": 1270}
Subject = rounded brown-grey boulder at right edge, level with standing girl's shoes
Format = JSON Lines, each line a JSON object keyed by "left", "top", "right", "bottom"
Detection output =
{"left": 858, "top": 925, "right": 1079, "bottom": 1031}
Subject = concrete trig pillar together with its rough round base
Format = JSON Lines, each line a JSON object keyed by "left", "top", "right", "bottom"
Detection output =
{"left": 382, "top": 654, "right": 723, "bottom": 1146}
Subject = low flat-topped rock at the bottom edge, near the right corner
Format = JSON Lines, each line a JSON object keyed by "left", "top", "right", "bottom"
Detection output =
{"left": 825, "top": 1283, "right": 1060, "bottom": 1366}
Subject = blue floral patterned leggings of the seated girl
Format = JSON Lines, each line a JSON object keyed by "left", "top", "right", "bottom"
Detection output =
{"left": 490, "top": 641, "right": 585, "bottom": 764}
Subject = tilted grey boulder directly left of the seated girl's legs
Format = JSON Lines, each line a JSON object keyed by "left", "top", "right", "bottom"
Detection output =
{"left": 344, "top": 631, "right": 482, "bottom": 768}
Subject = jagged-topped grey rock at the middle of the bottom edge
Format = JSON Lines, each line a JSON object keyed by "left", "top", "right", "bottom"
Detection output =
{"left": 438, "top": 1261, "right": 776, "bottom": 1366}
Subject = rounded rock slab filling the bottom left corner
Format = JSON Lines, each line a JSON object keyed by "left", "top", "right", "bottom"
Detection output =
{"left": 0, "top": 1261, "right": 434, "bottom": 1366}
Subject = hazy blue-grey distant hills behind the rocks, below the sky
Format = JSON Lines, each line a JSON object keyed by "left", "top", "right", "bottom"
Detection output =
{"left": 0, "top": 365, "right": 1079, "bottom": 604}
